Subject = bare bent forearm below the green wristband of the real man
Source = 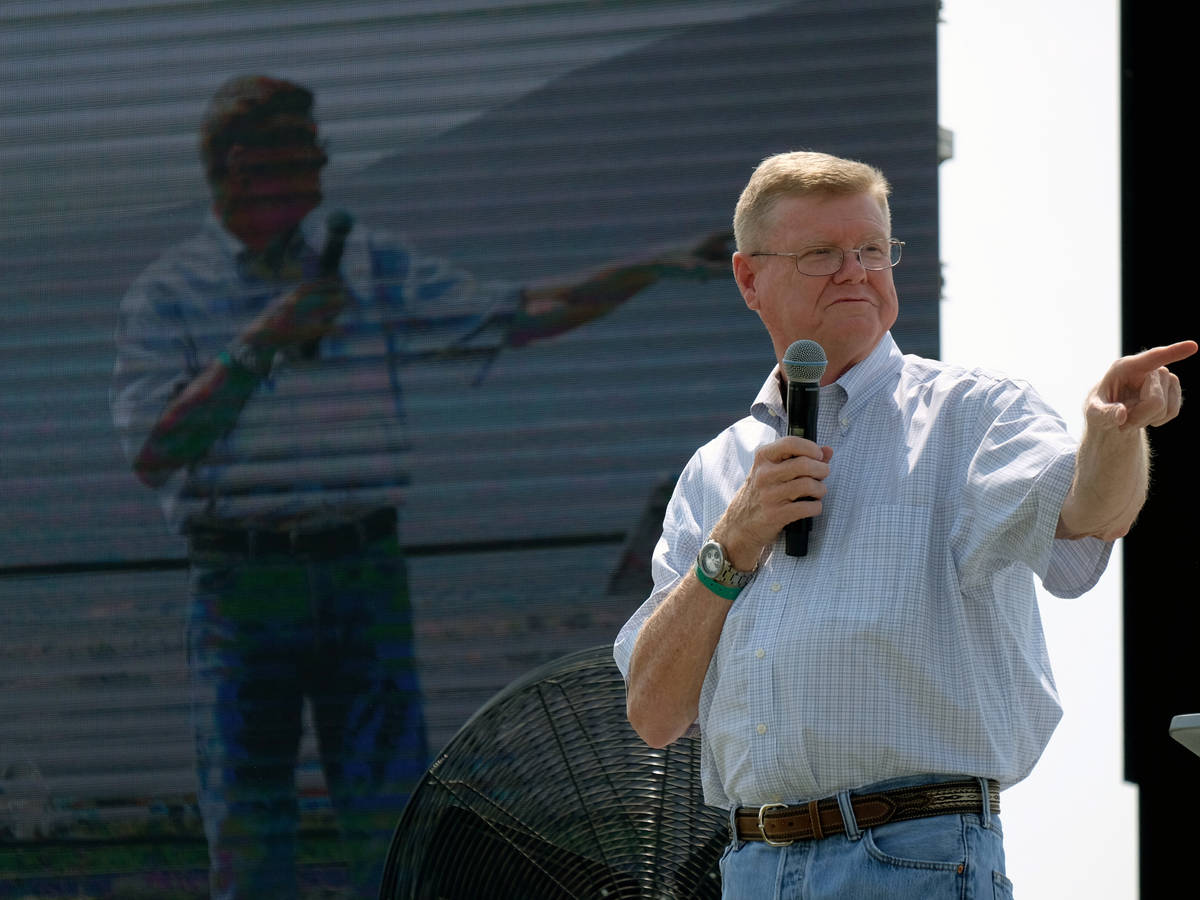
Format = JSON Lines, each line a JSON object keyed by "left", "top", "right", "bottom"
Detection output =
{"left": 626, "top": 572, "right": 732, "bottom": 746}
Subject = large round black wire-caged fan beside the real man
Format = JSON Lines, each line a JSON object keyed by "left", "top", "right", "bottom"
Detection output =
{"left": 379, "top": 646, "right": 728, "bottom": 900}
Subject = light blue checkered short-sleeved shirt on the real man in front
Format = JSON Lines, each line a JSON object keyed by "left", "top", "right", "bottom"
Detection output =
{"left": 616, "top": 335, "right": 1111, "bottom": 808}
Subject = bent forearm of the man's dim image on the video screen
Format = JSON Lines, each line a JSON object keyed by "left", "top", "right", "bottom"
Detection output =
{"left": 133, "top": 358, "right": 259, "bottom": 487}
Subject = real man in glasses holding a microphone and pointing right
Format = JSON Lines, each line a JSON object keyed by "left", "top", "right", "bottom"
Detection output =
{"left": 616, "top": 152, "right": 1196, "bottom": 900}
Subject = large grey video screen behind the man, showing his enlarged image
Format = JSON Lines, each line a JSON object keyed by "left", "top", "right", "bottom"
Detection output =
{"left": 0, "top": 0, "right": 940, "bottom": 898}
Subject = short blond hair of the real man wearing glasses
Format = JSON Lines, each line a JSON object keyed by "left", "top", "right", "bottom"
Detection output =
{"left": 733, "top": 150, "right": 892, "bottom": 252}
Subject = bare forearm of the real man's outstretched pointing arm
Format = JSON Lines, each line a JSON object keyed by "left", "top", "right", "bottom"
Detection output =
{"left": 1056, "top": 427, "right": 1150, "bottom": 540}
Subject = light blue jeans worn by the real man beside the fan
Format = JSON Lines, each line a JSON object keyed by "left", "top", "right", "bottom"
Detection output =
{"left": 721, "top": 779, "right": 1013, "bottom": 900}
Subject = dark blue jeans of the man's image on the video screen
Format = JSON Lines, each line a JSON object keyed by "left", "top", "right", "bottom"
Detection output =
{"left": 188, "top": 538, "right": 428, "bottom": 900}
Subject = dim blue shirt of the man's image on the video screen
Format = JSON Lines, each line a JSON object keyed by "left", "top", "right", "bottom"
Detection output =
{"left": 110, "top": 212, "right": 521, "bottom": 530}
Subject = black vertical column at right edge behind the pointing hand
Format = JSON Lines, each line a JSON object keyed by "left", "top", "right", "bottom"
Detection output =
{"left": 1121, "top": 0, "right": 1200, "bottom": 900}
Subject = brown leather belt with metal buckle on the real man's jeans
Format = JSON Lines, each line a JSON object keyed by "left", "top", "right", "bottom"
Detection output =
{"left": 733, "top": 780, "right": 1000, "bottom": 846}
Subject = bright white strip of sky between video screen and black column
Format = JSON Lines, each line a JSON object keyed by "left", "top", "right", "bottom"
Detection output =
{"left": 936, "top": 0, "right": 1132, "bottom": 900}
